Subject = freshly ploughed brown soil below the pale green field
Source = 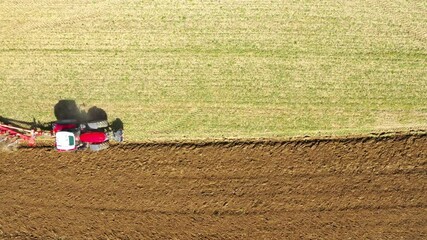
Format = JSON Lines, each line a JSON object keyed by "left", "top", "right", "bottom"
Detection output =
{"left": 0, "top": 134, "right": 427, "bottom": 239}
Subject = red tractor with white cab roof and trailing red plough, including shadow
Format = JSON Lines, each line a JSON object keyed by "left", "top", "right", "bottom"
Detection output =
{"left": 0, "top": 100, "right": 123, "bottom": 152}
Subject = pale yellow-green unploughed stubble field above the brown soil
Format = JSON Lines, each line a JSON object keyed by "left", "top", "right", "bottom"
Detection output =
{"left": 0, "top": 0, "right": 427, "bottom": 141}
